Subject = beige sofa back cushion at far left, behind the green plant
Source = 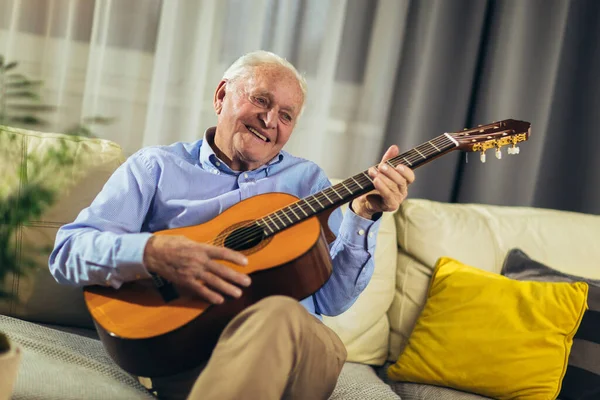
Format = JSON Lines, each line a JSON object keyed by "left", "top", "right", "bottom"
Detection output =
{"left": 0, "top": 127, "right": 124, "bottom": 327}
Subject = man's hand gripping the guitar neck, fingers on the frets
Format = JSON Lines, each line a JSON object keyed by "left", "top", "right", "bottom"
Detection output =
{"left": 351, "top": 145, "right": 415, "bottom": 219}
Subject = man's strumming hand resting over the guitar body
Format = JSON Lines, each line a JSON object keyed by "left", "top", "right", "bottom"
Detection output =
{"left": 144, "top": 235, "right": 250, "bottom": 304}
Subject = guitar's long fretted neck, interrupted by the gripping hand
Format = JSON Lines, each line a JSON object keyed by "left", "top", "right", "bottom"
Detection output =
{"left": 256, "top": 134, "right": 458, "bottom": 236}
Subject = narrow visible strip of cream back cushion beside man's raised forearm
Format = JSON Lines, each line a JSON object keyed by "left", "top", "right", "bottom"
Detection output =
{"left": 323, "top": 184, "right": 398, "bottom": 365}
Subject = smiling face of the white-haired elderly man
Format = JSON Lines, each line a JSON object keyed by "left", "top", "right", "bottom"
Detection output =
{"left": 213, "top": 64, "right": 304, "bottom": 171}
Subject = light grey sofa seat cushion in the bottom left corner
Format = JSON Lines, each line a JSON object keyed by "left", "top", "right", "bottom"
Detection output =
{"left": 0, "top": 315, "right": 155, "bottom": 400}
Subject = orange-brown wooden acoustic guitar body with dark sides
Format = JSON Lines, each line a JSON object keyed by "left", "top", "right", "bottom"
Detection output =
{"left": 84, "top": 193, "right": 332, "bottom": 377}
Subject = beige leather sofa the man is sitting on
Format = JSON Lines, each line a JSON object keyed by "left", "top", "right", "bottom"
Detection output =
{"left": 0, "top": 124, "right": 600, "bottom": 400}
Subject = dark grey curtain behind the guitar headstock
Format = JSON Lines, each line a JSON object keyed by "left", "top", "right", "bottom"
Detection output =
{"left": 384, "top": 0, "right": 600, "bottom": 214}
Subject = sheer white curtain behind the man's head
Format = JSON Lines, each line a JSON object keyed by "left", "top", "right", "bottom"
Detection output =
{"left": 0, "top": 0, "right": 409, "bottom": 177}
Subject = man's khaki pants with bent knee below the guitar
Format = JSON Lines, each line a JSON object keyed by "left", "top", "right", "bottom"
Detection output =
{"left": 146, "top": 296, "right": 346, "bottom": 400}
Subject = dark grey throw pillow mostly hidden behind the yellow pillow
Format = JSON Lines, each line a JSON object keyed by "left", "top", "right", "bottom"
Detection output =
{"left": 502, "top": 249, "right": 600, "bottom": 400}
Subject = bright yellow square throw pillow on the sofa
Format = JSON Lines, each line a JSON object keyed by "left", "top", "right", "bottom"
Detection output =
{"left": 388, "top": 257, "right": 588, "bottom": 400}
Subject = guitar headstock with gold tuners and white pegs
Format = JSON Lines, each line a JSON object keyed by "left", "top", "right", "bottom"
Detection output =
{"left": 448, "top": 119, "right": 531, "bottom": 162}
